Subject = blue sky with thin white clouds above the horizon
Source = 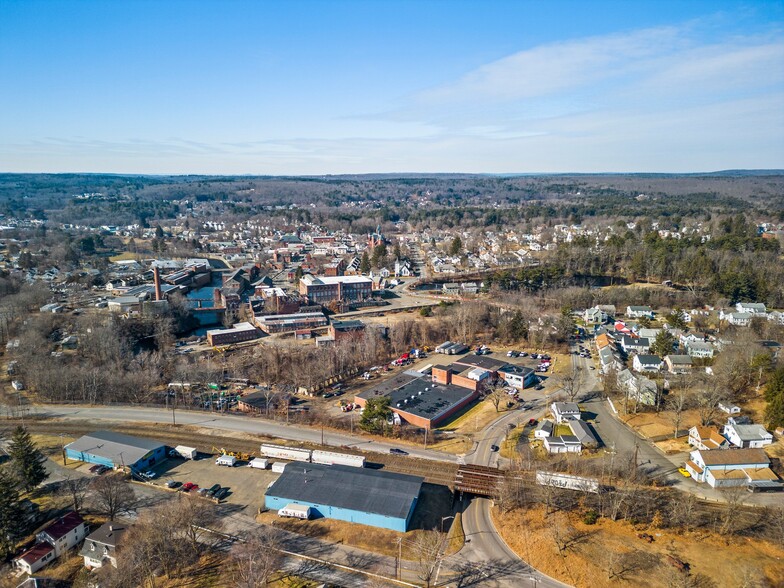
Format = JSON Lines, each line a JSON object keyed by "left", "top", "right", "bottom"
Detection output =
{"left": 0, "top": 0, "right": 784, "bottom": 175}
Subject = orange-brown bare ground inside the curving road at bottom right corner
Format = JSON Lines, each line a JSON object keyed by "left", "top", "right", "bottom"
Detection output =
{"left": 493, "top": 508, "right": 784, "bottom": 588}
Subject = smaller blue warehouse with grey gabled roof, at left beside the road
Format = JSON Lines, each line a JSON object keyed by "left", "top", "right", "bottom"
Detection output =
{"left": 65, "top": 431, "right": 166, "bottom": 471}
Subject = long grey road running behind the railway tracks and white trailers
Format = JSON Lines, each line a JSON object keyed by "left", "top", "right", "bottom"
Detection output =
{"left": 23, "top": 405, "right": 457, "bottom": 462}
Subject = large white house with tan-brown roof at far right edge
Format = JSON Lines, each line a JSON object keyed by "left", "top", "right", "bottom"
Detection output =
{"left": 685, "top": 449, "right": 778, "bottom": 488}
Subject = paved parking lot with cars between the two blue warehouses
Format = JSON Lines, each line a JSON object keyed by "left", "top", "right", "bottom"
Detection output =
{"left": 142, "top": 456, "right": 279, "bottom": 514}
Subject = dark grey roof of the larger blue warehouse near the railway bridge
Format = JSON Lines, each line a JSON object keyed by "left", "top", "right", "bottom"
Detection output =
{"left": 266, "top": 463, "right": 424, "bottom": 519}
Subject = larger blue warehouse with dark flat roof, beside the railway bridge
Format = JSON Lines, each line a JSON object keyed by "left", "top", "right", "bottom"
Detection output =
{"left": 264, "top": 463, "right": 424, "bottom": 532}
